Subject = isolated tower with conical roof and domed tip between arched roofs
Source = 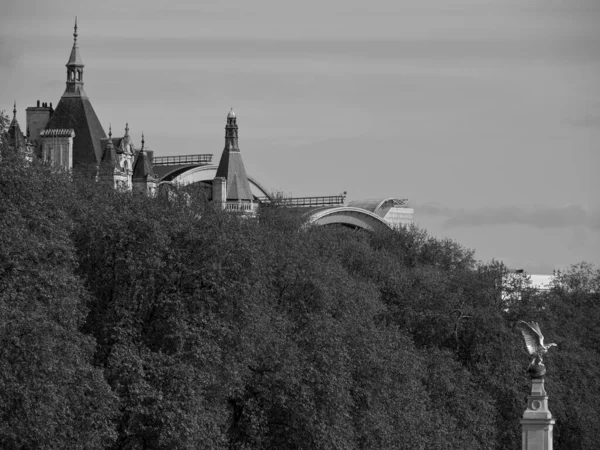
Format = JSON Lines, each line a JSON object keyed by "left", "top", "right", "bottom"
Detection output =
{"left": 213, "top": 108, "right": 258, "bottom": 215}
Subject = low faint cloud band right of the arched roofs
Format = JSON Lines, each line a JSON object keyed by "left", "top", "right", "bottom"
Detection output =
{"left": 415, "top": 203, "right": 600, "bottom": 231}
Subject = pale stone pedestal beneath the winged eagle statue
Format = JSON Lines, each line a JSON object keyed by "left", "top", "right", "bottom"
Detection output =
{"left": 521, "top": 378, "right": 555, "bottom": 450}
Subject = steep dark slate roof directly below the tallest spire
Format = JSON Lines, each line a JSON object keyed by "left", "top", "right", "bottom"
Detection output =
{"left": 46, "top": 95, "right": 106, "bottom": 166}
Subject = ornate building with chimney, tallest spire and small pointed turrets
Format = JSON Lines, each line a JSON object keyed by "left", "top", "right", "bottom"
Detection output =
{"left": 16, "top": 19, "right": 158, "bottom": 195}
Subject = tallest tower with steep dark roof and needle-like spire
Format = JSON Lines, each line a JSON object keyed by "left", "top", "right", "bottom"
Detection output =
{"left": 41, "top": 19, "right": 106, "bottom": 170}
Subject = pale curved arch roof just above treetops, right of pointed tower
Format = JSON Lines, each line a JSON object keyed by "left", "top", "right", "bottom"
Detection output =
{"left": 307, "top": 206, "right": 391, "bottom": 231}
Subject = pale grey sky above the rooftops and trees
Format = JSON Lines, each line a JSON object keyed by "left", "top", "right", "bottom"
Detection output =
{"left": 0, "top": 0, "right": 600, "bottom": 274}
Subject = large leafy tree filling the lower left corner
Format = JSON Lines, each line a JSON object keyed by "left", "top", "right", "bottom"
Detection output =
{"left": 0, "top": 151, "right": 116, "bottom": 449}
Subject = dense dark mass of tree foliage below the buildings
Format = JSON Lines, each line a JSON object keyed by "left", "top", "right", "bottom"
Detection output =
{"left": 0, "top": 125, "right": 600, "bottom": 449}
